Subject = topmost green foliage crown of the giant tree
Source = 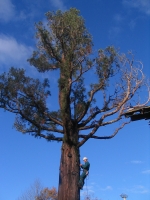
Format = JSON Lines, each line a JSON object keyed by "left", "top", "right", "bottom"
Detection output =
{"left": 29, "top": 8, "right": 92, "bottom": 74}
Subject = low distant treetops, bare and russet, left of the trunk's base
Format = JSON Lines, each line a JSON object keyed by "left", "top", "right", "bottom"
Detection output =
{"left": 18, "top": 180, "right": 58, "bottom": 200}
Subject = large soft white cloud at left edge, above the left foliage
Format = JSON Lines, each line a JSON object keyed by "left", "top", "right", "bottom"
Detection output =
{"left": 0, "top": 35, "right": 33, "bottom": 66}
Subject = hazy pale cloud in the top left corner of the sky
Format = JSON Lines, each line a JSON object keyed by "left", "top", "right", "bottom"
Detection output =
{"left": 0, "top": 0, "right": 15, "bottom": 22}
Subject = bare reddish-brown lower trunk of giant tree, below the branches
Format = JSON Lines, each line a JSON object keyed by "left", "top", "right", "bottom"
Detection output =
{"left": 58, "top": 142, "right": 80, "bottom": 200}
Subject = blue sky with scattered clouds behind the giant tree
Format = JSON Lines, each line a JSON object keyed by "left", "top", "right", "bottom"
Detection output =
{"left": 0, "top": 0, "right": 150, "bottom": 200}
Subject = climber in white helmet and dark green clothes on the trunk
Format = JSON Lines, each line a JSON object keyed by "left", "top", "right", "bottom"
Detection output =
{"left": 78, "top": 157, "right": 90, "bottom": 190}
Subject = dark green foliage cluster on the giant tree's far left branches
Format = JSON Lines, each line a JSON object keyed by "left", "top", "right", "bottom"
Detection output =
{"left": 0, "top": 67, "right": 50, "bottom": 133}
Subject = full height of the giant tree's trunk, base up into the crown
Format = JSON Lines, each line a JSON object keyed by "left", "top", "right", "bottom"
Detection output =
{"left": 58, "top": 57, "right": 80, "bottom": 200}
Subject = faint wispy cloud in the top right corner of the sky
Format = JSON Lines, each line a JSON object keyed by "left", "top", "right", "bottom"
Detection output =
{"left": 123, "top": 0, "right": 150, "bottom": 15}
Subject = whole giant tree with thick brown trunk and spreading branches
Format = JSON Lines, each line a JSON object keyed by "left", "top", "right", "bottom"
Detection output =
{"left": 0, "top": 8, "right": 150, "bottom": 200}
